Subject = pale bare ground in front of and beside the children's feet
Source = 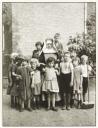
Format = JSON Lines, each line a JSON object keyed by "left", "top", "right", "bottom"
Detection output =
{"left": 2, "top": 80, "right": 95, "bottom": 126}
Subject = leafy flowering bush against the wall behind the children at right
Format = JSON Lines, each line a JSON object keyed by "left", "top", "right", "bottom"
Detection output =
{"left": 67, "top": 15, "right": 96, "bottom": 62}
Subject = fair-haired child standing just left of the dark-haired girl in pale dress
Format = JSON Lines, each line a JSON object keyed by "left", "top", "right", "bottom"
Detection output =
{"left": 30, "top": 58, "right": 41, "bottom": 109}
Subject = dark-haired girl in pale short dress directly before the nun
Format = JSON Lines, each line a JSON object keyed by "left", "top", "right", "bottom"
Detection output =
{"left": 42, "top": 57, "right": 59, "bottom": 111}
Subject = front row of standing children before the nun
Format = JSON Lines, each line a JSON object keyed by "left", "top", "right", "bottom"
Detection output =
{"left": 9, "top": 46, "right": 91, "bottom": 112}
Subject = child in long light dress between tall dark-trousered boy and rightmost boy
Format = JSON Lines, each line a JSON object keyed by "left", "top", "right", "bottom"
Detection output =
{"left": 72, "top": 57, "right": 82, "bottom": 108}
